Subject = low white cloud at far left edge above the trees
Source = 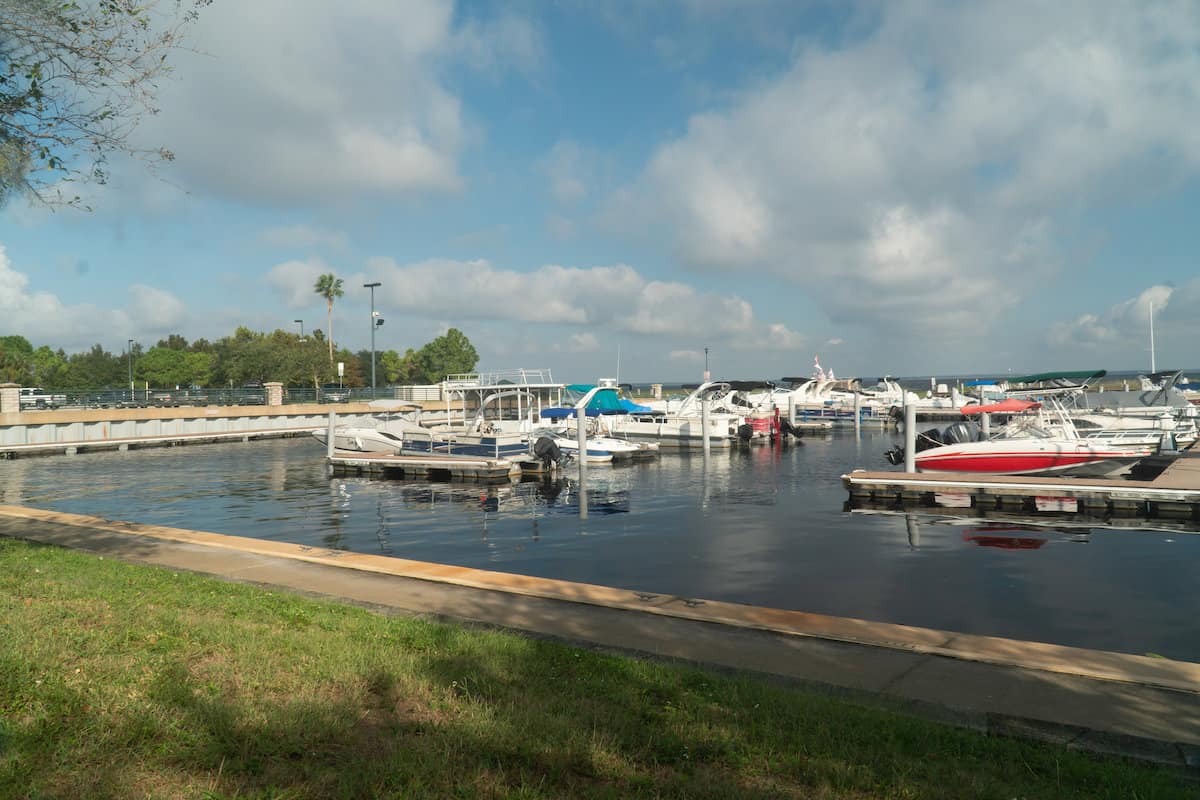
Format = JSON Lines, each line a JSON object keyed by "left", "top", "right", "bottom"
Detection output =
{"left": 0, "top": 245, "right": 188, "bottom": 349}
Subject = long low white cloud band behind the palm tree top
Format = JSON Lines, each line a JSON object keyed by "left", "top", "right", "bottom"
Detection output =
{"left": 345, "top": 258, "right": 799, "bottom": 348}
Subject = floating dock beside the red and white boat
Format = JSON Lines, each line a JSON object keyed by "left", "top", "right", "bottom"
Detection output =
{"left": 841, "top": 447, "right": 1200, "bottom": 522}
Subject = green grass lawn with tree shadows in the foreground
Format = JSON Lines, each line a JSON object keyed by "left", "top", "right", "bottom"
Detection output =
{"left": 0, "top": 537, "right": 1198, "bottom": 800}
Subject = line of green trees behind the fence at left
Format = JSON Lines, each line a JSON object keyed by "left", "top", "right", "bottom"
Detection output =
{"left": 0, "top": 327, "right": 479, "bottom": 391}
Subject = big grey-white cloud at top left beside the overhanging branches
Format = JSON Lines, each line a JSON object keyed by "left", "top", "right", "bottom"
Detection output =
{"left": 138, "top": 0, "right": 541, "bottom": 205}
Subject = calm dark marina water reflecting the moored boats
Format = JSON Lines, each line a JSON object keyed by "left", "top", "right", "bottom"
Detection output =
{"left": 0, "top": 432, "right": 1200, "bottom": 661}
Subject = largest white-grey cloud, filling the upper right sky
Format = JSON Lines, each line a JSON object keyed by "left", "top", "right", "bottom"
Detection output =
{"left": 606, "top": 0, "right": 1200, "bottom": 344}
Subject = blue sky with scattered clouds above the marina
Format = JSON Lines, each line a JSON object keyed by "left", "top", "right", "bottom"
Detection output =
{"left": 0, "top": 0, "right": 1200, "bottom": 383}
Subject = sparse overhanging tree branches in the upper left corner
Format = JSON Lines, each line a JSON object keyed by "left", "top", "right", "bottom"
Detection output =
{"left": 0, "top": 0, "right": 209, "bottom": 205}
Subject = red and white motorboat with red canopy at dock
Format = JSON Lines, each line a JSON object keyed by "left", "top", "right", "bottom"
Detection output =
{"left": 888, "top": 398, "right": 1157, "bottom": 477}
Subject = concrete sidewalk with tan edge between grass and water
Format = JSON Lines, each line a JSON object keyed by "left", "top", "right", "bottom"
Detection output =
{"left": 0, "top": 506, "right": 1200, "bottom": 770}
